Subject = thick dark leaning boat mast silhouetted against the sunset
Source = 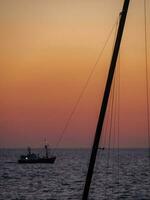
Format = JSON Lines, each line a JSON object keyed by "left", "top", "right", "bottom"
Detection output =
{"left": 82, "top": 0, "right": 130, "bottom": 200}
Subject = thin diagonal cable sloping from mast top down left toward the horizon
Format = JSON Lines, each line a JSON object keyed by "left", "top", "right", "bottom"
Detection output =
{"left": 55, "top": 17, "right": 118, "bottom": 148}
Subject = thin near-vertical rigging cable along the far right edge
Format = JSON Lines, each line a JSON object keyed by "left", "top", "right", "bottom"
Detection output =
{"left": 144, "top": 0, "right": 150, "bottom": 160}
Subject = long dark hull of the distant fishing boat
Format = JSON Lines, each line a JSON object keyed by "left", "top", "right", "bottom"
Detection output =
{"left": 18, "top": 156, "right": 56, "bottom": 164}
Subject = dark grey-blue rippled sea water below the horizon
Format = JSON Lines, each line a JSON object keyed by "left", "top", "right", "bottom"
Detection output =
{"left": 0, "top": 149, "right": 150, "bottom": 200}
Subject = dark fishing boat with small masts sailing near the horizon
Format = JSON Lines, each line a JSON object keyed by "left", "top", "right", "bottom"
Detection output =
{"left": 18, "top": 145, "right": 56, "bottom": 164}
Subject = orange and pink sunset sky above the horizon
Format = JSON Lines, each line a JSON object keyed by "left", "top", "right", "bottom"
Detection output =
{"left": 0, "top": 0, "right": 150, "bottom": 148}
